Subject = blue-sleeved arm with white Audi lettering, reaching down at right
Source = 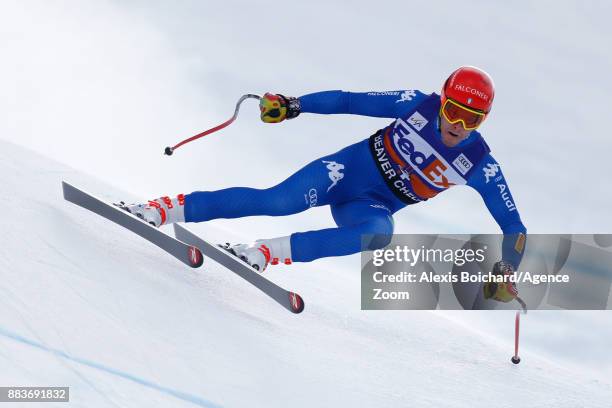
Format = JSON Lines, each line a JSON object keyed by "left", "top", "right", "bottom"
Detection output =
{"left": 468, "top": 154, "right": 527, "bottom": 270}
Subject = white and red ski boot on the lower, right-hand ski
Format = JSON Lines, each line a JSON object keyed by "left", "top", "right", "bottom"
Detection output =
{"left": 221, "top": 236, "right": 292, "bottom": 272}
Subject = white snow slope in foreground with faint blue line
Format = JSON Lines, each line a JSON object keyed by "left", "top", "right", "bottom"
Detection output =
{"left": 0, "top": 142, "right": 612, "bottom": 408}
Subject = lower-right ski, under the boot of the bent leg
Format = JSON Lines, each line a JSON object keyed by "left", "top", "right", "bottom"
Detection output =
{"left": 174, "top": 224, "right": 304, "bottom": 313}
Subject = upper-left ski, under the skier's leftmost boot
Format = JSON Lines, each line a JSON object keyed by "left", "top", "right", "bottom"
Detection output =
{"left": 62, "top": 181, "right": 204, "bottom": 268}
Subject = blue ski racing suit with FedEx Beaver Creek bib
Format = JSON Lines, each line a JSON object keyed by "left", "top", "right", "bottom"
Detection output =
{"left": 185, "top": 90, "right": 526, "bottom": 268}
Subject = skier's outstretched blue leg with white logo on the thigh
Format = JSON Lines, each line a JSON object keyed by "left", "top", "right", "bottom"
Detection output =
{"left": 185, "top": 142, "right": 380, "bottom": 222}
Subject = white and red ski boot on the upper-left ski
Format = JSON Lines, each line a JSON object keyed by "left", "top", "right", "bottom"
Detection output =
{"left": 117, "top": 194, "right": 185, "bottom": 227}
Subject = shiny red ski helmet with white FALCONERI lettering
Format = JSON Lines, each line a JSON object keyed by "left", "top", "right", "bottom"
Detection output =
{"left": 440, "top": 66, "right": 495, "bottom": 114}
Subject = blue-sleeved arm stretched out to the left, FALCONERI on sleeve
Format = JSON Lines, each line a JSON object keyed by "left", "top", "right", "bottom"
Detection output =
{"left": 299, "top": 90, "right": 427, "bottom": 119}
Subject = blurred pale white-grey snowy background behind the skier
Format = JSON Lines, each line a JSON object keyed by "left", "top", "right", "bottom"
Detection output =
{"left": 0, "top": 0, "right": 612, "bottom": 378}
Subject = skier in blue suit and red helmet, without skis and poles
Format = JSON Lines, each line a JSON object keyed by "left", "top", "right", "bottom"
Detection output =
{"left": 127, "top": 66, "right": 526, "bottom": 302}
